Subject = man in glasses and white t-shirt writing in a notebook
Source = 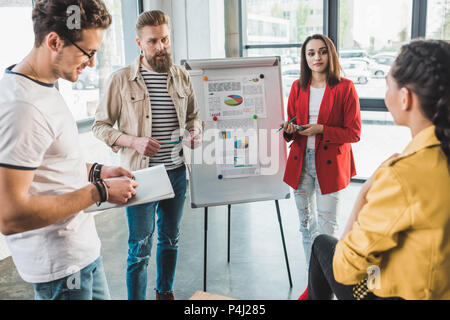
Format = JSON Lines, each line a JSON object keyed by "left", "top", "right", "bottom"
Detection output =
{"left": 0, "top": 0, "right": 137, "bottom": 299}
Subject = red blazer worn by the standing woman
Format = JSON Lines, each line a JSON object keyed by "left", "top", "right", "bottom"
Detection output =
{"left": 283, "top": 78, "right": 361, "bottom": 194}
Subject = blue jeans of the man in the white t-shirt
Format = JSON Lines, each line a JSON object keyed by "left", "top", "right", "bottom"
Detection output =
{"left": 33, "top": 257, "right": 111, "bottom": 300}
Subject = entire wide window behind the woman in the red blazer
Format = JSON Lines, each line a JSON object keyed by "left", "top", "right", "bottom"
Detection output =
{"left": 242, "top": 0, "right": 450, "bottom": 179}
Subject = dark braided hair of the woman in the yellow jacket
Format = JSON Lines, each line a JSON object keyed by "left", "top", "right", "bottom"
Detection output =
{"left": 391, "top": 40, "right": 450, "bottom": 166}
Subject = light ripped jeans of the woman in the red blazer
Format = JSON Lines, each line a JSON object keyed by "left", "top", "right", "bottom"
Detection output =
{"left": 294, "top": 149, "right": 339, "bottom": 270}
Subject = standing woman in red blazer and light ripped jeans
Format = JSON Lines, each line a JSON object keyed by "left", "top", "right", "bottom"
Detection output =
{"left": 284, "top": 34, "right": 361, "bottom": 269}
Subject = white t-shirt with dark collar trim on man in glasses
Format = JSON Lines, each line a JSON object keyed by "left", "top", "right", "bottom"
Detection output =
{"left": 0, "top": 67, "right": 100, "bottom": 283}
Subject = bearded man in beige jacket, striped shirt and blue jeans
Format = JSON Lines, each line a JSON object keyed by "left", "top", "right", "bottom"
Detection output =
{"left": 92, "top": 10, "right": 202, "bottom": 300}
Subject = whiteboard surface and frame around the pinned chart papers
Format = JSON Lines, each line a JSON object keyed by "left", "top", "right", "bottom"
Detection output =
{"left": 182, "top": 57, "right": 290, "bottom": 208}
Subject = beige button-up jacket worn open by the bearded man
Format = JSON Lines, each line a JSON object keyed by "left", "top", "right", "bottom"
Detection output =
{"left": 92, "top": 55, "right": 203, "bottom": 170}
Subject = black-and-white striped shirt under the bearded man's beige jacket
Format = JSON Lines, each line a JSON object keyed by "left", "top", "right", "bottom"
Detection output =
{"left": 140, "top": 65, "right": 184, "bottom": 170}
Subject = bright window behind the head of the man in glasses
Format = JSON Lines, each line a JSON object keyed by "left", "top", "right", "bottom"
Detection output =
{"left": 0, "top": 0, "right": 125, "bottom": 120}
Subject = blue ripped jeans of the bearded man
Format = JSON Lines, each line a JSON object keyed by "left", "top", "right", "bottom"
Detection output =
{"left": 127, "top": 166, "right": 186, "bottom": 300}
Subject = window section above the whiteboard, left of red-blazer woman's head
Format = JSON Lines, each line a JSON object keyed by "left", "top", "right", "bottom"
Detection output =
{"left": 243, "top": 0, "right": 323, "bottom": 105}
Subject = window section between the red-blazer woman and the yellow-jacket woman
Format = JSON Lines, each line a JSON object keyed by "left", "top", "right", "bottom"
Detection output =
{"left": 338, "top": 0, "right": 413, "bottom": 179}
